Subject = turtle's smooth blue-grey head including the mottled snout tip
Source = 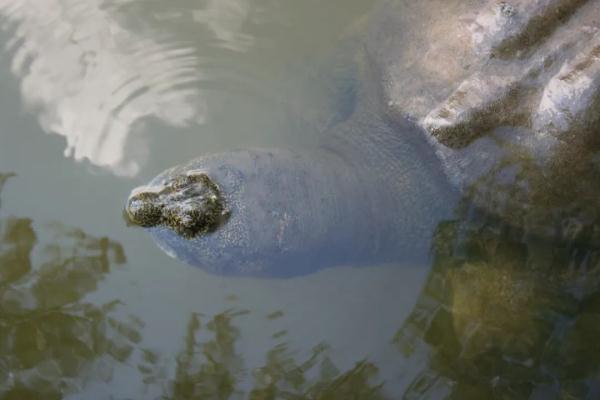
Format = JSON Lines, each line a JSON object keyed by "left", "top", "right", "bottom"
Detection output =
{"left": 125, "top": 149, "right": 398, "bottom": 277}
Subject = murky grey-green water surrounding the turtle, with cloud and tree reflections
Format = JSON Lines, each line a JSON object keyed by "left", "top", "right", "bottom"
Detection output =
{"left": 0, "top": 0, "right": 600, "bottom": 399}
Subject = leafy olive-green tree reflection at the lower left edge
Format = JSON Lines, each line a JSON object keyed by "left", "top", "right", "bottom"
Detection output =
{"left": 0, "top": 174, "right": 140, "bottom": 400}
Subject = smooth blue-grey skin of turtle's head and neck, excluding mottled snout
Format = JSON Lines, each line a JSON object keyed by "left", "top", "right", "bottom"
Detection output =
{"left": 128, "top": 89, "right": 456, "bottom": 277}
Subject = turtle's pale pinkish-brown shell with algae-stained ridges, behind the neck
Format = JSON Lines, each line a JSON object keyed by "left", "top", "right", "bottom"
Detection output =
{"left": 367, "top": 0, "right": 600, "bottom": 238}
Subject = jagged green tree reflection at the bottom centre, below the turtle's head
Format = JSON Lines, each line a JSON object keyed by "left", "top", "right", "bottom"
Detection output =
{"left": 154, "top": 311, "right": 384, "bottom": 400}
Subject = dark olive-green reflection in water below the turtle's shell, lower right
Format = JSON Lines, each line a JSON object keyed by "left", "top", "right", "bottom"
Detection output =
{"left": 394, "top": 200, "right": 600, "bottom": 400}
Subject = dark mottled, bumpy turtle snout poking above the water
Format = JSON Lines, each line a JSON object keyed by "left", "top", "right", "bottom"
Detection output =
{"left": 125, "top": 171, "right": 231, "bottom": 239}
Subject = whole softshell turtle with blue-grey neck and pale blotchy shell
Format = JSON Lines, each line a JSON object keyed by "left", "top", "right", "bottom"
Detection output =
{"left": 125, "top": 0, "right": 600, "bottom": 277}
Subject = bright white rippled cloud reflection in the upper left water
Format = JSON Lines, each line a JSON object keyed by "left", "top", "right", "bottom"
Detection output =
{"left": 0, "top": 0, "right": 204, "bottom": 175}
